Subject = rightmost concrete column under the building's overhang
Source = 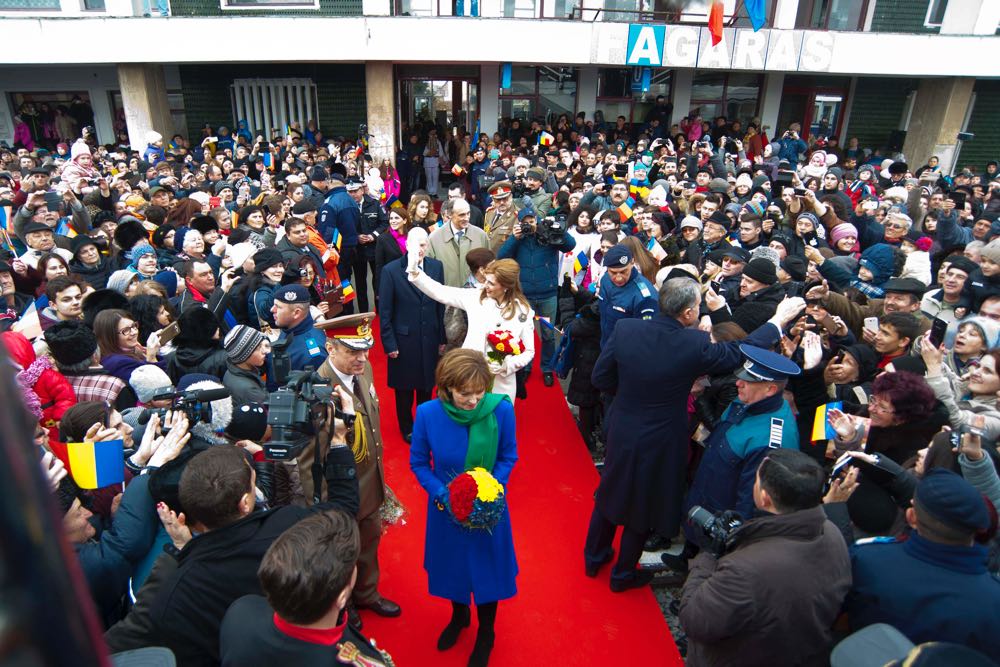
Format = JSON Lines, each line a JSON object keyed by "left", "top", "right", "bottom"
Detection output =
{"left": 903, "top": 77, "right": 976, "bottom": 173}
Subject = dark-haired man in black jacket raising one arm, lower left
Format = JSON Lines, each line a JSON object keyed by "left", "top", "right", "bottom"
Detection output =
{"left": 113, "top": 388, "right": 358, "bottom": 665}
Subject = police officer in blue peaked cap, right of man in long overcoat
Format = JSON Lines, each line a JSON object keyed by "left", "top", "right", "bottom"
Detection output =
{"left": 668, "top": 344, "right": 802, "bottom": 552}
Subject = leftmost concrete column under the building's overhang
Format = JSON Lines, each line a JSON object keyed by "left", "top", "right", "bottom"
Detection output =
{"left": 116, "top": 63, "right": 174, "bottom": 151}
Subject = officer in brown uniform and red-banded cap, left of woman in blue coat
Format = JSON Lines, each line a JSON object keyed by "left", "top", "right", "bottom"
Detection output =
{"left": 312, "top": 313, "right": 400, "bottom": 627}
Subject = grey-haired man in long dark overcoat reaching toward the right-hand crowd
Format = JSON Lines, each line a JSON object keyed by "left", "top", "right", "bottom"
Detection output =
{"left": 584, "top": 278, "right": 805, "bottom": 592}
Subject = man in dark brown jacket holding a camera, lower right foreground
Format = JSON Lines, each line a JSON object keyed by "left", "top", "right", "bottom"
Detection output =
{"left": 680, "top": 449, "right": 851, "bottom": 667}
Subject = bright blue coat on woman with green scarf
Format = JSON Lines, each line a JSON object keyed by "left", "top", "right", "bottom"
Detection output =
{"left": 410, "top": 399, "right": 517, "bottom": 604}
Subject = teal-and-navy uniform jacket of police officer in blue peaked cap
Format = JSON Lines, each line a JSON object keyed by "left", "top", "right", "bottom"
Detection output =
{"left": 684, "top": 393, "right": 799, "bottom": 542}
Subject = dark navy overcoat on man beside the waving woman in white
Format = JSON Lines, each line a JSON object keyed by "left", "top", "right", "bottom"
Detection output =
{"left": 378, "top": 256, "right": 445, "bottom": 391}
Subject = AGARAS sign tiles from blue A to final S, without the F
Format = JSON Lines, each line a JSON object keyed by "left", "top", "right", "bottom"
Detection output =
{"left": 625, "top": 24, "right": 834, "bottom": 72}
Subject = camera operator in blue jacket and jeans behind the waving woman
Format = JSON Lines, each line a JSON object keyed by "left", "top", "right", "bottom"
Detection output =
{"left": 497, "top": 205, "right": 576, "bottom": 387}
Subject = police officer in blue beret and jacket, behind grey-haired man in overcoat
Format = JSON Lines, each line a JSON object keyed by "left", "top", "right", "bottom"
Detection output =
{"left": 597, "top": 243, "right": 659, "bottom": 347}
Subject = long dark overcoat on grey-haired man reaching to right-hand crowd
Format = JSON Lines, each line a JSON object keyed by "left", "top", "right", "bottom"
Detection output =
{"left": 592, "top": 315, "right": 781, "bottom": 535}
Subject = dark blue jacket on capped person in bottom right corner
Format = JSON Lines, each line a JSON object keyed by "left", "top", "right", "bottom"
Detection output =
{"left": 846, "top": 533, "right": 1000, "bottom": 661}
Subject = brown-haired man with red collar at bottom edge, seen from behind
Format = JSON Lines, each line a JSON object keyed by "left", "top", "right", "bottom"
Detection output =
{"left": 219, "top": 510, "right": 391, "bottom": 667}
